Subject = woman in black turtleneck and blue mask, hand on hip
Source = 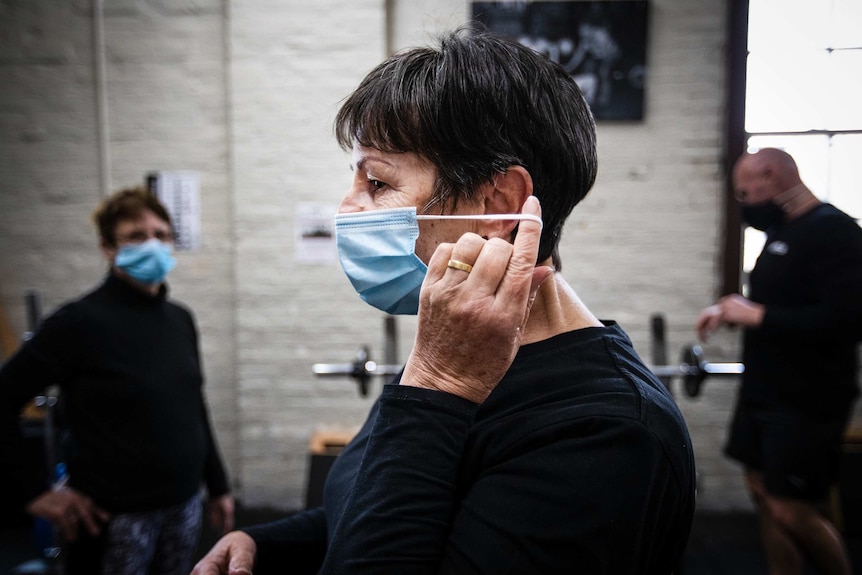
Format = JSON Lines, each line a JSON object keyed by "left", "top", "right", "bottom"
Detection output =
{"left": 0, "top": 188, "right": 234, "bottom": 575}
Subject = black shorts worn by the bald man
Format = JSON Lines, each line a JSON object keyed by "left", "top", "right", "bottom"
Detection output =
{"left": 724, "top": 399, "right": 851, "bottom": 502}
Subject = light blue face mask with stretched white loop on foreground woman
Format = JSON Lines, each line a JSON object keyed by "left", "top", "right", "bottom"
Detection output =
{"left": 335, "top": 208, "right": 541, "bottom": 315}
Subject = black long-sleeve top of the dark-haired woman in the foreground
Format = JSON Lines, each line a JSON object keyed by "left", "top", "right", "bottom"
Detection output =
{"left": 245, "top": 326, "right": 695, "bottom": 575}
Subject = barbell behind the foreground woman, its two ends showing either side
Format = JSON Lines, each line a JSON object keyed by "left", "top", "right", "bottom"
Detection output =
{"left": 312, "top": 344, "right": 745, "bottom": 397}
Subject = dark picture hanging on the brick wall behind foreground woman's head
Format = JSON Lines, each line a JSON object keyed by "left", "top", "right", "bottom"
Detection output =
{"left": 472, "top": 0, "right": 648, "bottom": 121}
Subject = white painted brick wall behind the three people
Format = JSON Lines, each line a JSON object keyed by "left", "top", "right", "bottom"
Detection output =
{"left": 5, "top": 0, "right": 856, "bottom": 509}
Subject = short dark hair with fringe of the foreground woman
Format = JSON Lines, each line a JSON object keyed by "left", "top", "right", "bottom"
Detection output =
{"left": 335, "top": 29, "right": 597, "bottom": 268}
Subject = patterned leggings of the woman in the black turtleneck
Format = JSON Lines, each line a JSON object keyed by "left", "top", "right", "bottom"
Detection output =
{"left": 102, "top": 494, "right": 203, "bottom": 575}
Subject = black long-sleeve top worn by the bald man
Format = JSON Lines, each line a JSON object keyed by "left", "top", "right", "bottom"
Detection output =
{"left": 742, "top": 204, "right": 862, "bottom": 416}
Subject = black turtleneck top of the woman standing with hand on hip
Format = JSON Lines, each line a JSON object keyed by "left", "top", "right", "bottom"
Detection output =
{"left": 0, "top": 275, "right": 229, "bottom": 513}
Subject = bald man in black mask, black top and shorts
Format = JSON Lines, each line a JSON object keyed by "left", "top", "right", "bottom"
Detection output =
{"left": 695, "top": 148, "right": 862, "bottom": 575}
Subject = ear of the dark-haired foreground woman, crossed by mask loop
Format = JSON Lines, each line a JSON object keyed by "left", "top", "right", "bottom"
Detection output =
{"left": 479, "top": 166, "right": 533, "bottom": 241}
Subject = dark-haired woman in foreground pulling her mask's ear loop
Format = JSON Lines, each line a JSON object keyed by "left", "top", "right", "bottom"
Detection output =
{"left": 193, "top": 32, "right": 695, "bottom": 575}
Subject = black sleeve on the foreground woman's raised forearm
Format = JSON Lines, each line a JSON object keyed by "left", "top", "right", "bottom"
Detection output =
{"left": 321, "top": 385, "right": 477, "bottom": 575}
